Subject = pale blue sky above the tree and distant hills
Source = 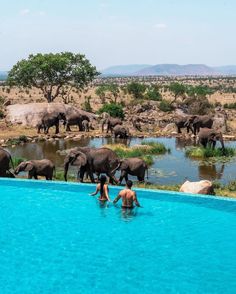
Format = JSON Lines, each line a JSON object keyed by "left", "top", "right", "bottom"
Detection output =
{"left": 0, "top": 0, "right": 236, "bottom": 70}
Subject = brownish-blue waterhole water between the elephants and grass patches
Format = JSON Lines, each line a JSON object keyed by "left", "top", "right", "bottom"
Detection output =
{"left": 9, "top": 138, "right": 236, "bottom": 185}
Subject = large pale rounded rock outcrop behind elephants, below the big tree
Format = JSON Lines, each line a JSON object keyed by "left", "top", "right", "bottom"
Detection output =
{"left": 6, "top": 103, "right": 97, "bottom": 127}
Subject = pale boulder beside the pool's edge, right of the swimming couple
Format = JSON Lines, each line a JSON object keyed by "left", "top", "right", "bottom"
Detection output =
{"left": 179, "top": 180, "right": 214, "bottom": 195}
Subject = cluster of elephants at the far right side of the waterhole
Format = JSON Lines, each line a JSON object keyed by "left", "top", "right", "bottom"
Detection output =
{"left": 175, "top": 115, "right": 225, "bottom": 149}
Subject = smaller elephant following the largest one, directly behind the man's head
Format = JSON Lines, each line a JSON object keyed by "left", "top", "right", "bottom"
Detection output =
{"left": 112, "top": 157, "right": 148, "bottom": 184}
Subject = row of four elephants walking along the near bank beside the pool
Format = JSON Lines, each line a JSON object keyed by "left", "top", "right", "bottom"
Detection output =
{"left": 0, "top": 147, "right": 148, "bottom": 184}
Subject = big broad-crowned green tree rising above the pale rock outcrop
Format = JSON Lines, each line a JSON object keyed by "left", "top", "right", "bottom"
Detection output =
{"left": 7, "top": 52, "right": 99, "bottom": 102}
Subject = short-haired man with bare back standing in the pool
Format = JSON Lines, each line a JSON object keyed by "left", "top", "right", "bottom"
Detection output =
{"left": 113, "top": 180, "right": 141, "bottom": 209}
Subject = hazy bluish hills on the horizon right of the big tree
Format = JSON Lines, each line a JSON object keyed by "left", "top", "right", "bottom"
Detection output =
{"left": 102, "top": 64, "right": 236, "bottom": 76}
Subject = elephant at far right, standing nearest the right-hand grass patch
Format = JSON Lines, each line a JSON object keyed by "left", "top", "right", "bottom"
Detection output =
{"left": 198, "top": 128, "right": 225, "bottom": 149}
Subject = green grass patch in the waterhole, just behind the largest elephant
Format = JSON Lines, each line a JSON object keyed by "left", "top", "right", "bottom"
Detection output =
{"left": 105, "top": 141, "right": 170, "bottom": 166}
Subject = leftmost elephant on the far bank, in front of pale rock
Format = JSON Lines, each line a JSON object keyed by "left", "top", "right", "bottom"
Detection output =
{"left": 37, "top": 112, "right": 66, "bottom": 134}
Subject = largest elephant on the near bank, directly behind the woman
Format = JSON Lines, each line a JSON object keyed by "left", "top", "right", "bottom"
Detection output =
{"left": 64, "top": 147, "right": 120, "bottom": 183}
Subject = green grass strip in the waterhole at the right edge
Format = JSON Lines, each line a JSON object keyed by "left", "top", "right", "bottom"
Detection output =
{"left": 185, "top": 147, "right": 236, "bottom": 159}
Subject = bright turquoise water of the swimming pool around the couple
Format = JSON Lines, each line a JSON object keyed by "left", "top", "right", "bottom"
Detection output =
{"left": 0, "top": 180, "right": 236, "bottom": 294}
